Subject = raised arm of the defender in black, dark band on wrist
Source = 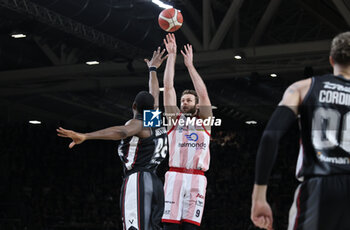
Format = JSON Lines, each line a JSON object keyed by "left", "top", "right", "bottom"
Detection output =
{"left": 144, "top": 47, "right": 168, "bottom": 108}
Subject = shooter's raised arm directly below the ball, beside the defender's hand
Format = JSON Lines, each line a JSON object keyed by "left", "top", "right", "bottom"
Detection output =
{"left": 164, "top": 34, "right": 180, "bottom": 114}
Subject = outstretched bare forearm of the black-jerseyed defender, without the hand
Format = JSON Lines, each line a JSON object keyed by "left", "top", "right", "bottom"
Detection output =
{"left": 84, "top": 126, "right": 128, "bottom": 140}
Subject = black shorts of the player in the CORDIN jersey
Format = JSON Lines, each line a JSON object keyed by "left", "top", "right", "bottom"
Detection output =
{"left": 288, "top": 175, "right": 350, "bottom": 230}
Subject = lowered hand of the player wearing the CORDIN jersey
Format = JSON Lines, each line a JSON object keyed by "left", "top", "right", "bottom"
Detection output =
{"left": 250, "top": 200, "right": 273, "bottom": 230}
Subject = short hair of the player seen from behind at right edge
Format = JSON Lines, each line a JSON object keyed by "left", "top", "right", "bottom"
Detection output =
{"left": 330, "top": 32, "right": 350, "bottom": 65}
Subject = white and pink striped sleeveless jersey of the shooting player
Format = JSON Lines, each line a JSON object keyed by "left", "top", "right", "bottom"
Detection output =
{"left": 168, "top": 114, "right": 210, "bottom": 171}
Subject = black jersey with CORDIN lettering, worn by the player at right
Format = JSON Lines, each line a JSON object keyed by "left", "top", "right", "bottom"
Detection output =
{"left": 297, "top": 75, "right": 350, "bottom": 180}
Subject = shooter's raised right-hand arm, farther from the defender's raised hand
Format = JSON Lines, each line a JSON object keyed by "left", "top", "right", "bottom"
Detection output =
{"left": 181, "top": 44, "right": 213, "bottom": 119}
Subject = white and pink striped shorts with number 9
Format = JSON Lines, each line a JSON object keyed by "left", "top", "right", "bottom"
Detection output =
{"left": 162, "top": 168, "right": 207, "bottom": 226}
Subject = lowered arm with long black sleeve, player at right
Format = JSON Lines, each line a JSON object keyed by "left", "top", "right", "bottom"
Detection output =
{"left": 251, "top": 79, "right": 311, "bottom": 229}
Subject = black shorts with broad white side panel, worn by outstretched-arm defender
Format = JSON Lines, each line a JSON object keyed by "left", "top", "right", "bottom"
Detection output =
{"left": 120, "top": 171, "right": 164, "bottom": 230}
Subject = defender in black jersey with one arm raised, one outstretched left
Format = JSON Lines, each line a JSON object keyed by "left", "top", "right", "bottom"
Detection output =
{"left": 57, "top": 48, "right": 168, "bottom": 230}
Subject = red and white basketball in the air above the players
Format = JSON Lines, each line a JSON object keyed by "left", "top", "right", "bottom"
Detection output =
{"left": 158, "top": 8, "right": 183, "bottom": 32}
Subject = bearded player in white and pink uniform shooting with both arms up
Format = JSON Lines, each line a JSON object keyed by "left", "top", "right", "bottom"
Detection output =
{"left": 162, "top": 34, "right": 212, "bottom": 230}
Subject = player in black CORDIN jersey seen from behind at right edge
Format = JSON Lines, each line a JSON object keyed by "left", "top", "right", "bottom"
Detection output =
{"left": 251, "top": 32, "right": 350, "bottom": 230}
